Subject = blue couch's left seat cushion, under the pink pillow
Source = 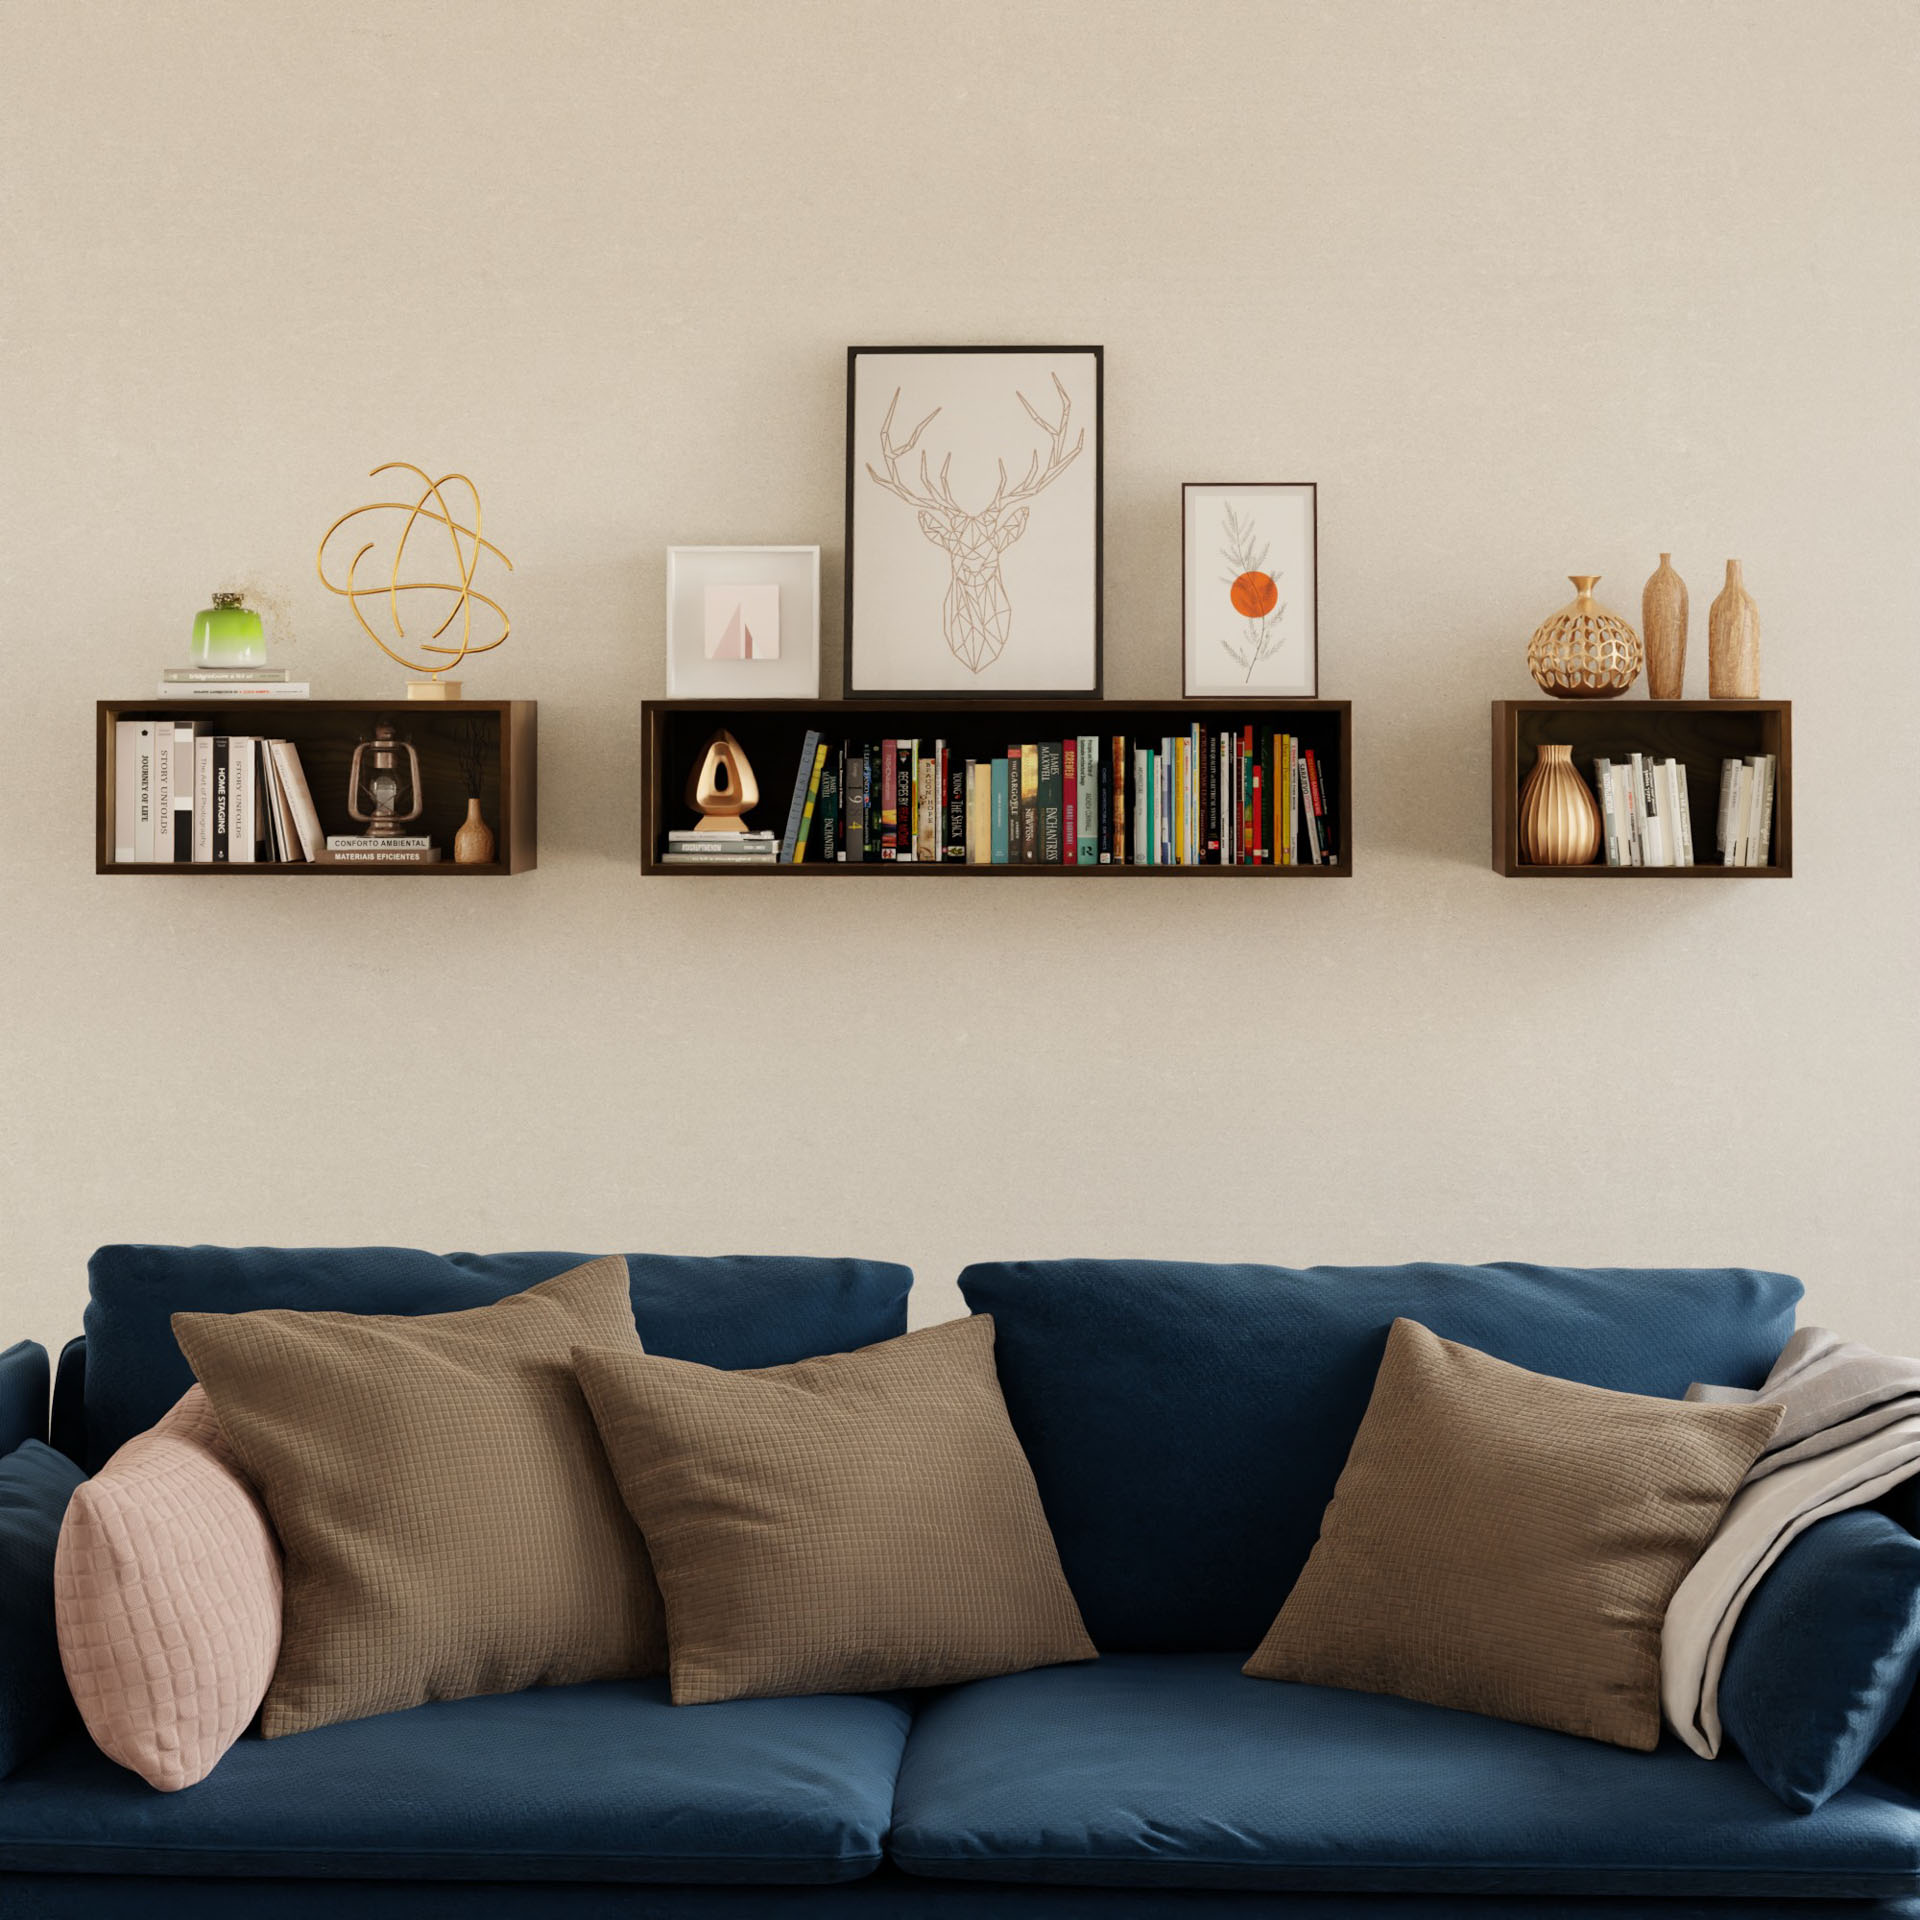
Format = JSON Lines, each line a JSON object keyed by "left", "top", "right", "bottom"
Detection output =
{"left": 0, "top": 1680, "right": 910, "bottom": 1885}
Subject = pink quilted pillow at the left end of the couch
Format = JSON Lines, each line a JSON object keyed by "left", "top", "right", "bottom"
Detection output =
{"left": 54, "top": 1386, "right": 280, "bottom": 1793}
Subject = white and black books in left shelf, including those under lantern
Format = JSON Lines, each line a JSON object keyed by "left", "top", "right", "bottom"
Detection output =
{"left": 113, "top": 720, "right": 440, "bottom": 866}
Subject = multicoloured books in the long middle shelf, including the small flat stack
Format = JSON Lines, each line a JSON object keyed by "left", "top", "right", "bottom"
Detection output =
{"left": 725, "top": 724, "right": 1338, "bottom": 866}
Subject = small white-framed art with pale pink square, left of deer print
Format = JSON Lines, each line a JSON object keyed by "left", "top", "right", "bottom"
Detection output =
{"left": 666, "top": 547, "right": 820, "bottom": 701}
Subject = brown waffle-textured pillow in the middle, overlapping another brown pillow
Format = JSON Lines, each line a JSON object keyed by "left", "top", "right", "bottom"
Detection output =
{"left": 574, "top": 1317, "right": 1094, "bottom": 1705}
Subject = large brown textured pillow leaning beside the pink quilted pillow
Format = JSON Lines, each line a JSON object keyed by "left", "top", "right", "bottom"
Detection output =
{"left": 173, "top": 1256, "right": 666, "bottom": 1740}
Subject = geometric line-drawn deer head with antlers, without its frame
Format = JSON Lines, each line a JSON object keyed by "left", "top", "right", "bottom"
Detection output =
{"left": 868, "top": 374, "right": 1087, "bottom": 674}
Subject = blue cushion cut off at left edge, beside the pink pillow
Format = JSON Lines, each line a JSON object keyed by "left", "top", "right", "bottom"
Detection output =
{"left": 0, "top": 1440, "right": 81, "bottom": 1780}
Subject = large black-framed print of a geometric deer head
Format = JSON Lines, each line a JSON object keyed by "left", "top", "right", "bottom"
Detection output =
{"left": 847, "top": 348, "right": 1102, "bottom": 699}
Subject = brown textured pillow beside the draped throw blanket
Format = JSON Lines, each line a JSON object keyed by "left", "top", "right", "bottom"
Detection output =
{"left": 1246, "top": 1319, "right": 1780, "bottom": 1749}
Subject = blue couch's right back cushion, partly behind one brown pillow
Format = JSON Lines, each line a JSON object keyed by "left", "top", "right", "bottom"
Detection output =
{"left": 960, "top": 1260, "right": 1801, "bottom": 1653}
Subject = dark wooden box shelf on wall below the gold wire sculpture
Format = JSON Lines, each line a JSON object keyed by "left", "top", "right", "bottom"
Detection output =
{"left": 94, "top": 699, "right": 540, "bottom": 879}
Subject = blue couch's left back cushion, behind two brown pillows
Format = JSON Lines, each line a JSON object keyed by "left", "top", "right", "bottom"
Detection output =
{"left": 86, "top": 1246, "right": 914, "bottom": 1467}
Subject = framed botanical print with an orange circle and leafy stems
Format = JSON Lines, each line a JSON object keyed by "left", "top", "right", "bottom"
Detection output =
{"left": 1181, "top": 480, "right": 1319, "bottom": 699}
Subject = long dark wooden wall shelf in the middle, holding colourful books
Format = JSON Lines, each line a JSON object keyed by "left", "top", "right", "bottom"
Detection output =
{"left": 641, "top": 699, "right": 1354, "bottom": 879}
